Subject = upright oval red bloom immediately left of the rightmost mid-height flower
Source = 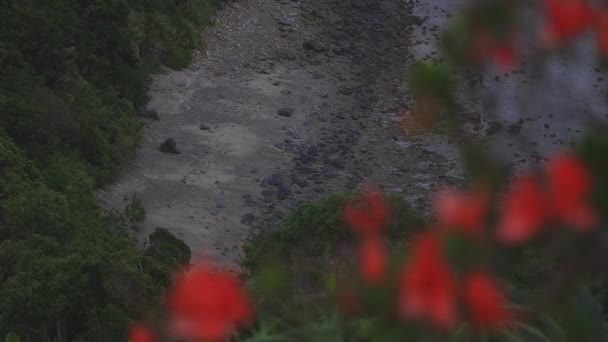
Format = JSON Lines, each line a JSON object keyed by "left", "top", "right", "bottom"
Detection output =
{"left": 497, "top": 176, "right": 547, "bottom": 244}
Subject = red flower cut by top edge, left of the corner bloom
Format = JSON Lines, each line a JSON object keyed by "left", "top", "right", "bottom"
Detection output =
{"left": 545, "top": 0, "right": 593, "bottom": 43}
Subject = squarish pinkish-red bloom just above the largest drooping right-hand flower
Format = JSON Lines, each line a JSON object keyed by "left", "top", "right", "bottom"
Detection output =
{"left": 434, "top": 189, "right": 488, "bottom": 237}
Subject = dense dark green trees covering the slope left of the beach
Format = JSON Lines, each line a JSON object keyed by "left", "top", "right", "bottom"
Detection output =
{"left": 0, "top": 0, "right": 216, "bottom": 341}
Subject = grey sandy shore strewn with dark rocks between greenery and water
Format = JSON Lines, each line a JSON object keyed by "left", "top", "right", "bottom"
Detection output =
{"left": 100, "top": 0, "right": 461, "bottom": 267}
